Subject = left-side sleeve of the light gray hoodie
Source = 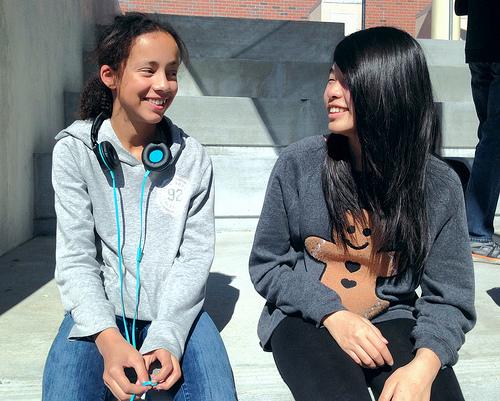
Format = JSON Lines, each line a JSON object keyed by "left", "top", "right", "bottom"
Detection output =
{"left": 52, "top": 138, "right": 116, "bottom": 338}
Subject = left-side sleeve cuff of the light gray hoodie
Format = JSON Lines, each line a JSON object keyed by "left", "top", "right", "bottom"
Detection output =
{"left": 68, "top": 304, "right": 118, "bottom": 340}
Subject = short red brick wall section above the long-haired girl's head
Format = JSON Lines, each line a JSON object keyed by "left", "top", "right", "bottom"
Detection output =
{"left": 366, "top": 0, "right": 432, "bottom": 36}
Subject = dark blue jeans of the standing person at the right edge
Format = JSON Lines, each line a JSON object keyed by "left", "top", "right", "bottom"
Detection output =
{"left": 465, "top": 63, "right": 500, "bottom": 242}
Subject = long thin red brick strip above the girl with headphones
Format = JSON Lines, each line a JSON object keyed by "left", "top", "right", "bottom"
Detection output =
{"left": 119, "top": 0, "right": 321, "bottom": 20}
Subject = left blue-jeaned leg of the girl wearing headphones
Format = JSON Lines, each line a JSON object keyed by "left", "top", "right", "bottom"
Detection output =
{"left": 42, "top": 313, "right": 111, "bottom": 401}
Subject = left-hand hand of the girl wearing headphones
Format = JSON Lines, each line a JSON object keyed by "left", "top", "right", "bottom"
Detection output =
{"left": 95, "top": 328, "right": 150, "bottom": 401}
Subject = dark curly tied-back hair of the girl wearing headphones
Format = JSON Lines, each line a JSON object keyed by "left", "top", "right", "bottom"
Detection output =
{"left": 80, "top": 13, "right": 189, "bottom": 120}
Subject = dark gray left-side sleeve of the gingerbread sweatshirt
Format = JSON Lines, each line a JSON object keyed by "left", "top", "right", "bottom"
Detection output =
{"left": 249, "top": 157, "right": 344, "bottom": 326}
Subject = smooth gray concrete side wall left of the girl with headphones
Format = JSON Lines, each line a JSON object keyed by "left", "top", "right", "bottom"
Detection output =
{"left": 0, "top": 0, "right": 118, "bottom": 255}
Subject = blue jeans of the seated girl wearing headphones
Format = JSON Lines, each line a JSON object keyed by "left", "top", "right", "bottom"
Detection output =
{"left": 42, "top": 312, "right": 236, "bottom": 401}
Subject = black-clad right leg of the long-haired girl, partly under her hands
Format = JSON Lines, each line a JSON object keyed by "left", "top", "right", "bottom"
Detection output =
{"left": 365, "top": 319, "right": 464, "bottom": 401}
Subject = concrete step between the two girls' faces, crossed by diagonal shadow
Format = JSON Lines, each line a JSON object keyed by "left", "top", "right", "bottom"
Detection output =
{"left": 65, "top": 93, "right": 327, "bottom": 146}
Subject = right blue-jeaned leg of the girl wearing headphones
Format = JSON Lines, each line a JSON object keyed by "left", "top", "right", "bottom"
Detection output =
{"left": 169, "top": 312, "right": 237, "bottom": 401}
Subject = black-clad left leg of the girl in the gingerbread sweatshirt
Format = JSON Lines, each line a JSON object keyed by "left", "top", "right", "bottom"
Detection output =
{"left": 271, "top": 316, "right": 371, "bottom": 401}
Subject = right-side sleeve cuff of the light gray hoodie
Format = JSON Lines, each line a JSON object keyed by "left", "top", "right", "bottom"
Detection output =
{"left": 140, "top": 320, "right": 186, "bottom": 361}
